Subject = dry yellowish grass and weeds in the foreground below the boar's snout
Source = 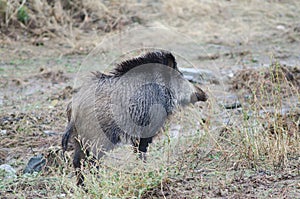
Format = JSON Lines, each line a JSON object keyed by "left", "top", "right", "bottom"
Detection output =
{"left": 1, "top": 63, "right": 300, "bottom": 198}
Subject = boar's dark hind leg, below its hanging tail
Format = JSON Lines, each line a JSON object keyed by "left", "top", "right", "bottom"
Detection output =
{"left": 73, "top": 141, "right": 86, "bottom": 185}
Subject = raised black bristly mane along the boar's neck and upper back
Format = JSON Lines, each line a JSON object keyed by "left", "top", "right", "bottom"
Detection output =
{"left": 111, "top": 51, "right": 178, "bottom": 76}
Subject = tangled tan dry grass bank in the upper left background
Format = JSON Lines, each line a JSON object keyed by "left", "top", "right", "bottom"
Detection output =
{"left": 0, "top": 0, "right": 157, "bottom": 45}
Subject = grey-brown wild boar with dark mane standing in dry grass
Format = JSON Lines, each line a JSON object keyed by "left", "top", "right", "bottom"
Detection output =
{"left": 62, "top": 51, "right": 207, "bottom": 184}
